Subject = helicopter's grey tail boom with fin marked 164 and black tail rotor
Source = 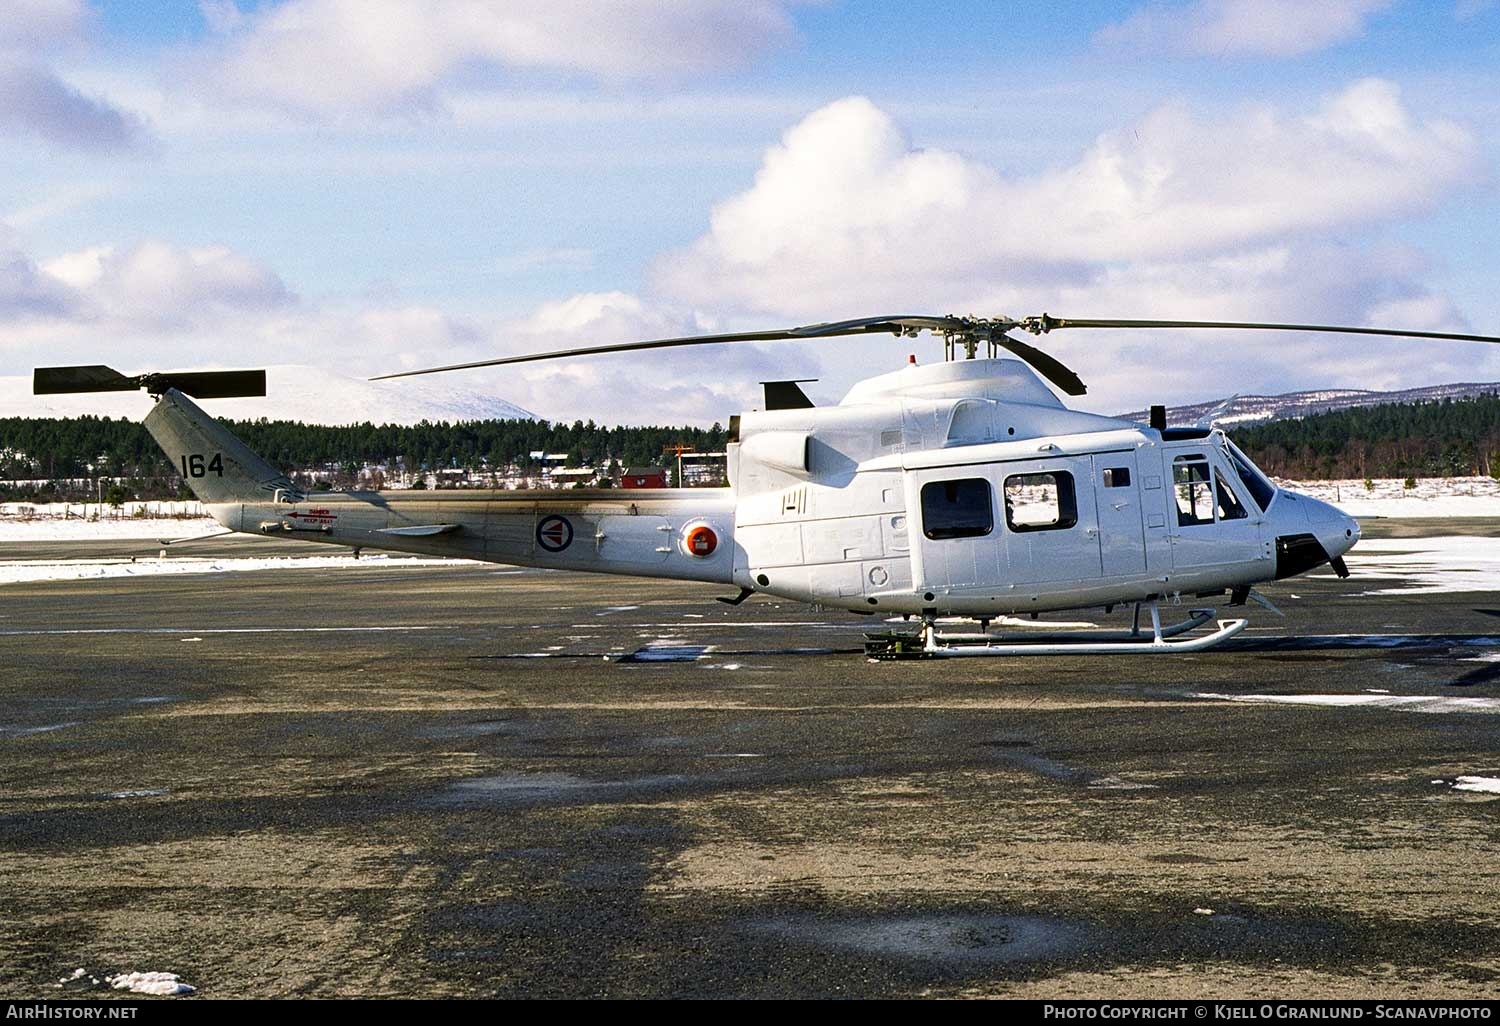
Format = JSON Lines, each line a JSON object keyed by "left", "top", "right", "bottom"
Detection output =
{"left": 43, "top": 366, "right": 747, "bottom": 584}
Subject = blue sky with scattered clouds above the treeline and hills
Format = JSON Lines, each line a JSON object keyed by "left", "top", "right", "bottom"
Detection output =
{"left": 0, "top": 0, "right": 1500, "bottom": 425}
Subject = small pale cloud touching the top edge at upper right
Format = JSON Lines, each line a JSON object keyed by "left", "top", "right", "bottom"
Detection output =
{"left": 1095, "top": 0, "right": 1391, "bottom": 57}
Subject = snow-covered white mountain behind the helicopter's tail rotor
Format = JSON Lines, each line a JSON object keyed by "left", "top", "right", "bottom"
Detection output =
{"left": 0, "top": 365, "right": 536, "bottom": 425}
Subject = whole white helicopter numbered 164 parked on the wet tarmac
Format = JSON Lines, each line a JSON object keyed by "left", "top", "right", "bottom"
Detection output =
{"left": 35, "top": 314, "right": 1500, "bottom": 659}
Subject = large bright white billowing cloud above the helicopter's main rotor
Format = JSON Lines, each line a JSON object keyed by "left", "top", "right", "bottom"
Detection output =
{"left": 656, "top": 87, "right": 1479, "bottom": 318}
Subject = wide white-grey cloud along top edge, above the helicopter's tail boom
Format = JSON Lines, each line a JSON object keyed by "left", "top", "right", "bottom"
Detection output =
{"left": 204, "top": 0, "right": 794, "bottom": 114}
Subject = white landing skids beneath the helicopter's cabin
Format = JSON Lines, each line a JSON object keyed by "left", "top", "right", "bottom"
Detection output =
{"left": 864, "top": 603, "right": 1250, "bottom": 660}
